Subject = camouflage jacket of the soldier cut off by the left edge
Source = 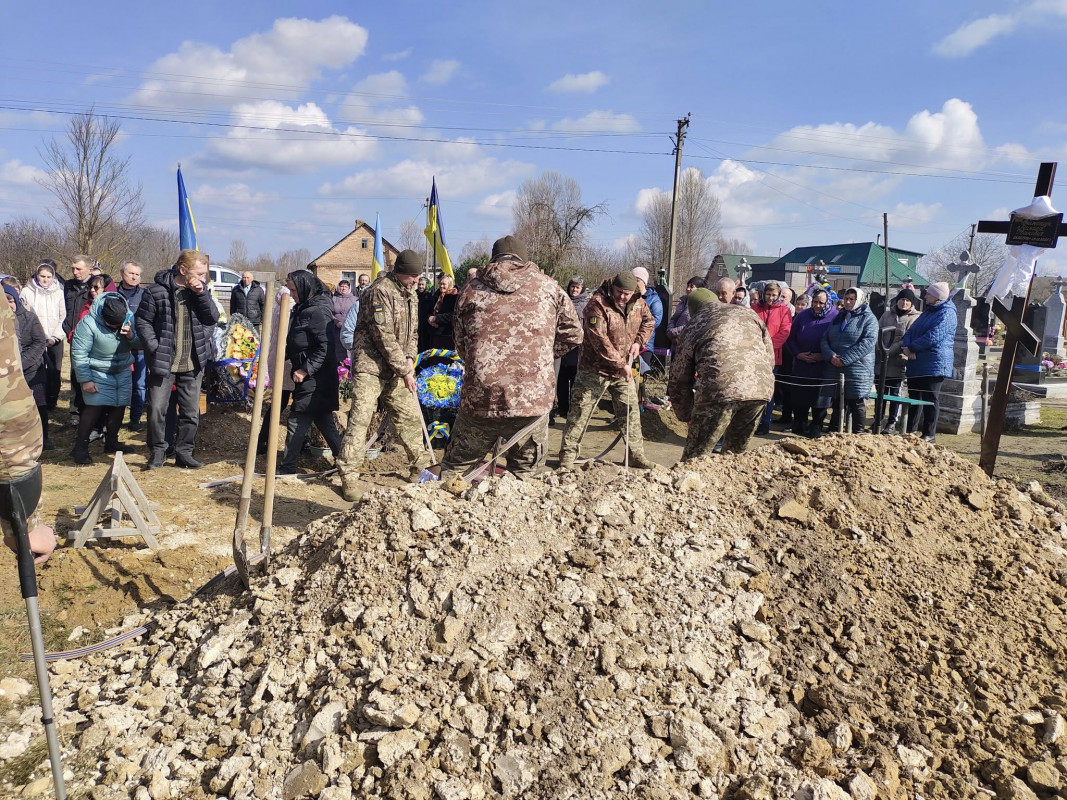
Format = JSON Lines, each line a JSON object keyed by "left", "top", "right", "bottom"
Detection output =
{"left": 0, "top": 302, "right": 44, "bottom": 481}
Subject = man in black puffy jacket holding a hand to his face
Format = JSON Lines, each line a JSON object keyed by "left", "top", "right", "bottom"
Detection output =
{"left": 137, "top": 250, "right": 219, "bottom": 469}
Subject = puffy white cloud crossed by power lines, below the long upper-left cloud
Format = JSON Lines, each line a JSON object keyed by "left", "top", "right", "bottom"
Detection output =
{"left": 209, "top": 100, "right": 378, "bottom": 173}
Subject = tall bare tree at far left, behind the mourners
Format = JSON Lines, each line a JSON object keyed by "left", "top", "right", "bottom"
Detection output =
{"left": 41, "top": 109, "right": 144, "bottom": 260}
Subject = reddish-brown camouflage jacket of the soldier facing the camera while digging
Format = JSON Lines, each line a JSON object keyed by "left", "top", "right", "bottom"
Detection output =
{"left": 578, "top": 281, "right": 655, "bottom": 378}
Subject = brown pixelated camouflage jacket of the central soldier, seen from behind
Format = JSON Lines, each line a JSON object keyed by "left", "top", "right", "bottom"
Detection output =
{"left": 452, "top": 256, "right": 582, "bottom": 419}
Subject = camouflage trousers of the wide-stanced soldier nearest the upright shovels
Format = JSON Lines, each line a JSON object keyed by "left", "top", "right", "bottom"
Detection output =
{"left": 335, "top": 372, "right": 430, "bottom": 482}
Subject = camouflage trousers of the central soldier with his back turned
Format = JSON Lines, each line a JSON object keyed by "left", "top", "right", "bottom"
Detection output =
{"left": 441, "top": 411, "right": 548, "bottom": 480}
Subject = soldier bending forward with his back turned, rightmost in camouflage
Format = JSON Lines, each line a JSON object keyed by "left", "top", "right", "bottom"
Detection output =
{"left": 667, "top": 290, "right": 775, "bottom": 461}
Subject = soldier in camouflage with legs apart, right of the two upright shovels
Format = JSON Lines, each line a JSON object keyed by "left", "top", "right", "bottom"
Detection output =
{"left": 336, "top": 250, "right": 430, "bottom": 501}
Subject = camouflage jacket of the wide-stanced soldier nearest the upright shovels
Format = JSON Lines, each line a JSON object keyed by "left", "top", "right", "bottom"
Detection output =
{"left": 352, "top": 274, "right": 418, "bottom": 379}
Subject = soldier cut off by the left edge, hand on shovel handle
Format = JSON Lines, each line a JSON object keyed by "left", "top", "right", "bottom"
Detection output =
{"left": 0, "top": 294, "right": 55, "bottom": 563}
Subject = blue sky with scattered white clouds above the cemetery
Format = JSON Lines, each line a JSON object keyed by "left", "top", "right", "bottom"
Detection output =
{"left": 0, "top": 0, "right": 1067, "bottom": 272}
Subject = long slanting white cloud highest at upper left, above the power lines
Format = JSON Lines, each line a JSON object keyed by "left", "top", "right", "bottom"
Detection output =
{"left": 132, "top": 16, "right": 367, "bottom": 108}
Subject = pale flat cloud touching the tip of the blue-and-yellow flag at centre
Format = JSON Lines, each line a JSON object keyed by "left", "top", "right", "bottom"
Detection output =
{"left": 319, "top": 141, "right": 535, "bottom": 198}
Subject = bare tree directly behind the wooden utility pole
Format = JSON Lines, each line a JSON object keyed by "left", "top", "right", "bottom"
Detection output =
{"left": 636, "top": 167, "right": 722, "bottom": 275}
